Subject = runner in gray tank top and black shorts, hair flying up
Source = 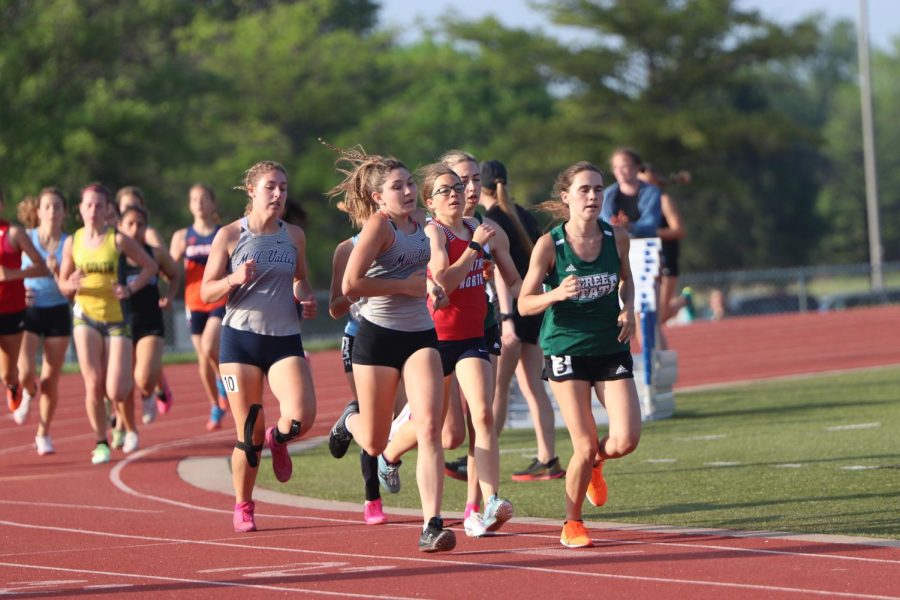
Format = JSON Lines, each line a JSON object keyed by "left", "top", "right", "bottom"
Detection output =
{"left": 320, "top": 141, "right": 456, "bottom": 552}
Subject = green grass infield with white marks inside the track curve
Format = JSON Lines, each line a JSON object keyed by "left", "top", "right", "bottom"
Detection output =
{"left": 259, "top": 368, "right": 900, "bottom": 539}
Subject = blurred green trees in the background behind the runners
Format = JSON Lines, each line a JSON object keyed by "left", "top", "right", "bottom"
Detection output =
{"left": 0, "top": 0, "right": 900, "bottom": 286}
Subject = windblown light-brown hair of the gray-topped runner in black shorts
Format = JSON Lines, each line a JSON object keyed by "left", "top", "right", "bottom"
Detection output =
{"left": 319, "top": 138, "right": 409, "bottom": 229}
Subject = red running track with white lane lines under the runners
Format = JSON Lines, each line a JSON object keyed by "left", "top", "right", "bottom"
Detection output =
{"left": 0, "top": 307, "right": 900, "bottom": 600}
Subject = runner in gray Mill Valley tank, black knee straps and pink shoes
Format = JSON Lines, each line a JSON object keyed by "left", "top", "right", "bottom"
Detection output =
{"left": 200, "top": 161, "right": 316, "bottom": 532}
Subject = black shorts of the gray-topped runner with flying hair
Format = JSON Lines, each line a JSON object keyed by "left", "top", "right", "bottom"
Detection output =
{"left": 351, "top": 319, "right": 437, "bottom": 371}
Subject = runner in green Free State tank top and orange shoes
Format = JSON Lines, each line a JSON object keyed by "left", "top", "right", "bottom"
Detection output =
{"left": 519, "top": 162, "right": 641, "bottom": 548}
